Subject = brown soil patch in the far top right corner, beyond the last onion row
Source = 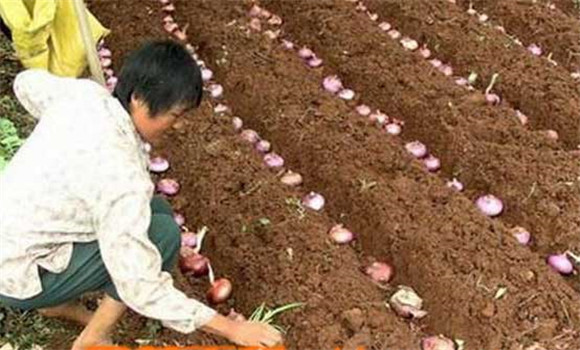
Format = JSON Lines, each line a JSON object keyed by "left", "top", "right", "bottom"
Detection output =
{"left": 457, "top": 0, "right": 580, "bottom": 73}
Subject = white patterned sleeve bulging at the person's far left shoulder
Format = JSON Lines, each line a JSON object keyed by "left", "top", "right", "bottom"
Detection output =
{"left": 14, "top": 69, "right": 75, "bottom": 119}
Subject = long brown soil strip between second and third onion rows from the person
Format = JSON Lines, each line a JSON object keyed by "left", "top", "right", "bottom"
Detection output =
{"left": 172, "top": 1, "right": 580, "bottom": 348}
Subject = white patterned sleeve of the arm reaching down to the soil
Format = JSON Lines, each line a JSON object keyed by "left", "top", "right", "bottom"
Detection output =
{"left": 97, "top": 190, "right": 216, "bottom": 333}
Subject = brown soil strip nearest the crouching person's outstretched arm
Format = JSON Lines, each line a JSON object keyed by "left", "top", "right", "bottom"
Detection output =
{"left": 91, "top": 0, "right": 420, "bottom": 350}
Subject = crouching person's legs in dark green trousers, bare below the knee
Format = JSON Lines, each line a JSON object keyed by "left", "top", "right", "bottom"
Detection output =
{"left": 0, "top": 209, "right": 181, "bottom": 350}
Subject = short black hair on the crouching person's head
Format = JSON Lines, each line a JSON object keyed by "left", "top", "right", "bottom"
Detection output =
{"left": 113, "top": 41, "right": 203, "bottom": 117}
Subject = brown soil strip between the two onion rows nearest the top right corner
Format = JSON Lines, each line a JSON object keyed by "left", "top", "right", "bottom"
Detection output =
{"left": 365, "top": 0, "right": 580, "bottom": 149}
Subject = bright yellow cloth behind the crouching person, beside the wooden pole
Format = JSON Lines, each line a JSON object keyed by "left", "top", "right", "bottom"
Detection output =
{"left": 0, "top": 0, "right": 109, "bottom": 77}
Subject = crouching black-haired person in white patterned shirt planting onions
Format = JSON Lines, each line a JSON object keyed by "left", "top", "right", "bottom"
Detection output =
{"left": 0, "top": 42, "right": 281, "bottom": 350}
